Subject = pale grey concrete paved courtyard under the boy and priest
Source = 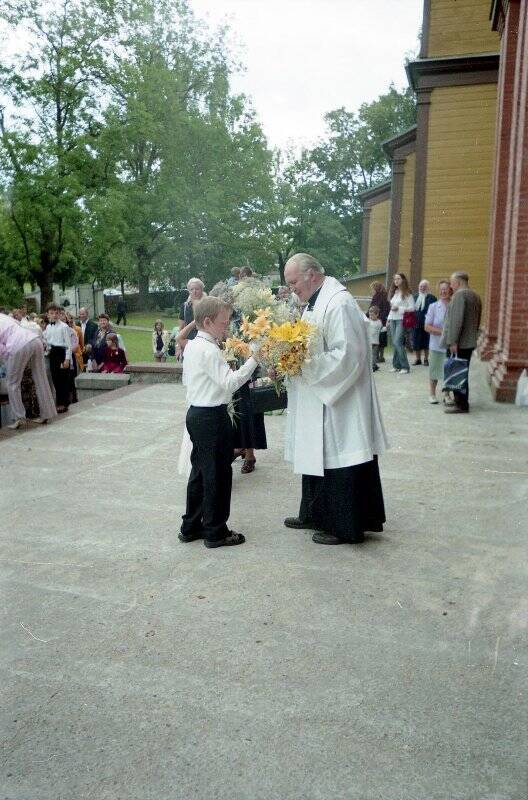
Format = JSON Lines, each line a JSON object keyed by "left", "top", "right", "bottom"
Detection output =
{"left": 0, "top": 364, "right": 528, "bottom": 800}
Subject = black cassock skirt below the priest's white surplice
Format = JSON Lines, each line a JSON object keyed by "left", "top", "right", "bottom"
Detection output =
{"left": 299, "top": 456, "right": 385, "bottom": 542}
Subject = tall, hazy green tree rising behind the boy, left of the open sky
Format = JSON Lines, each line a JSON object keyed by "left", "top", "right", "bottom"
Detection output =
{"left": 88, "top": 0, "right": 270, "bottom": 306}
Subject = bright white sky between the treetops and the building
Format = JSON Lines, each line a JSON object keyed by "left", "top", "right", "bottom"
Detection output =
{"left": 189, "top": 0, "right": 423, "bottom": 148}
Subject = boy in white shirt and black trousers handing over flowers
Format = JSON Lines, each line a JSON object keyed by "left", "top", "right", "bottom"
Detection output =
{"left": 178, "top": 297, "right": 257, "bottom": 547}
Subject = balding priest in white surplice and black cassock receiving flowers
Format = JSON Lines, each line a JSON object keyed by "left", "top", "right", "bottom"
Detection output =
{"left": 284, "top": 253, "right": 388, "bottom": 544}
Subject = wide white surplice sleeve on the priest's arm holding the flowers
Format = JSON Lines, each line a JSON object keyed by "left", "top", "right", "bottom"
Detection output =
{"left": 300, "top": 301, "right": 369, "bottom": 406}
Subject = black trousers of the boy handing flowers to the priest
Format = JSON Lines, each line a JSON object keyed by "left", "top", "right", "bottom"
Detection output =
{"left": 181, "top": 405, "right": 233, "bottom": 541}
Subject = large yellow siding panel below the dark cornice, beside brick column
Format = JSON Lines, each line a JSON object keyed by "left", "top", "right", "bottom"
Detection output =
{"left": 421, "top": 84, "right": 497, "bottom": 299}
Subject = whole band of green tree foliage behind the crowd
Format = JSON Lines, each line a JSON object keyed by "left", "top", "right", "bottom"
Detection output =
{"left": 0, "top": 0, "right": 415, "bottom": 298}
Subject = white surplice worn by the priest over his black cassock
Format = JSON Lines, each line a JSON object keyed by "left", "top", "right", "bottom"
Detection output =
{"left": 285, "top": 277, "right": 389, "bottom": 475}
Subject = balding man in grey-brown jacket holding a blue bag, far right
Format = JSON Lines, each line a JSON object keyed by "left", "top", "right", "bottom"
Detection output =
{"left": 441, "top": 272, "right": 482, "bottom": 414}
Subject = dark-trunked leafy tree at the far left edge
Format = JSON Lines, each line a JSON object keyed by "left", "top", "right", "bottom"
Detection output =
{"left": 0, "top": 0, "right": 112, "bottom": 306}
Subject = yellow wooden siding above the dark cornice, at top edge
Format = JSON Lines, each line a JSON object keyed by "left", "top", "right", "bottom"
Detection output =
{"left": 425, "top": 0, "right": 500, "bottom": 58}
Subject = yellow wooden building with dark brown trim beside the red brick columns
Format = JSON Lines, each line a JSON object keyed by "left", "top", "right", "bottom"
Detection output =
{"left": 358, "top": 0, "right": 500, "bottom": 298}
